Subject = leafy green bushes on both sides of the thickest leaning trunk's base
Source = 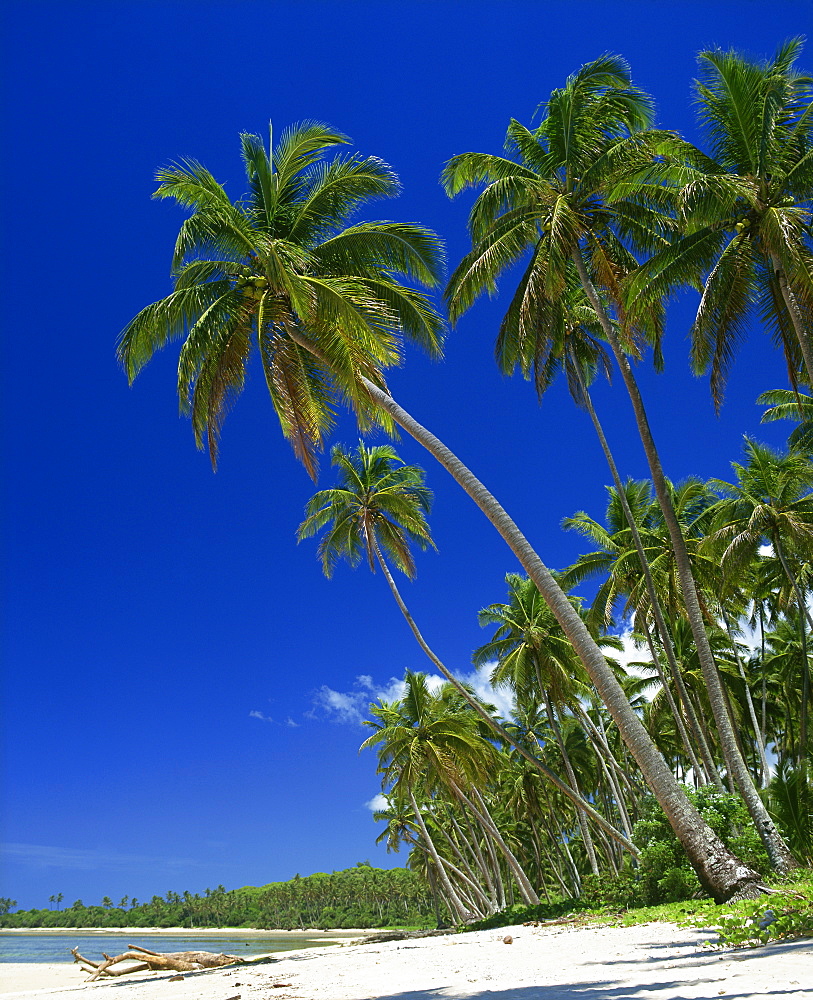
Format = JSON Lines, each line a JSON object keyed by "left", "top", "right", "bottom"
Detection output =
{"left": 632, "top": 785, "right": 770, "bottom": 906}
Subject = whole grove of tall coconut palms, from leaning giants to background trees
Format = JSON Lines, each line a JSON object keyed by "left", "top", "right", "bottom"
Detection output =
{"left": 108, "top": 40, "right": 813, "bottom": 923}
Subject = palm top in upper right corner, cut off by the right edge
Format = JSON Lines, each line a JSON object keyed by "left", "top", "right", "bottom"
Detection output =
{"left": 629, "top": 38, "right": 813, "bottom": 405}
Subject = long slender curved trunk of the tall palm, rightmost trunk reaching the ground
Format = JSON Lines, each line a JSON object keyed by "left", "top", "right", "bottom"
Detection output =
{"left": 573, "top": 251, "right": 798, "bottom": 872}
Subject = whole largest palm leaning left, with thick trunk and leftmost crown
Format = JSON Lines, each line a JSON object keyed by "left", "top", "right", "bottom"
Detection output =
{"left": 119, "top": 115, "right": 759, "bottom": 900}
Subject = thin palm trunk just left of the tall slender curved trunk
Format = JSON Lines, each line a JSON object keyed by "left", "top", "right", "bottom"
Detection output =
{"left": 575, "top": 365, "right": 722, "bottom": 788}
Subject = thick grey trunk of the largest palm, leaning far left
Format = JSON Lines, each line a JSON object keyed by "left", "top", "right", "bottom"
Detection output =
{"left": 289, "top": 330, "right": 773, "bottom": 902}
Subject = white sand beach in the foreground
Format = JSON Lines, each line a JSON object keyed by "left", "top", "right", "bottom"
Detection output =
{"left": 0, "top": 923, "right": 813, "bottom": 1000}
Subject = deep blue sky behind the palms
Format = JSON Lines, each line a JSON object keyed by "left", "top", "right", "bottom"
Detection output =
{"left": 0, "top": 0, "right": 813, "bottom": 906}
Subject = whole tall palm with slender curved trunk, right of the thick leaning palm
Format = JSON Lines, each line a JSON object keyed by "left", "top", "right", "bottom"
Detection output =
{"left": 442, "top": 56, "right": 794, "bottom": 871}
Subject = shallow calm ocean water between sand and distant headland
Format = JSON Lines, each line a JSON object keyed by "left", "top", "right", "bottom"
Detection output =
{"left": 0, "top": 930, "right": 332, "bottom": 963}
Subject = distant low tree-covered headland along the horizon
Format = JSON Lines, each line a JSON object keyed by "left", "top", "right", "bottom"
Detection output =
{"left": 0, "top": 863, "right": 436, "bottom": 930}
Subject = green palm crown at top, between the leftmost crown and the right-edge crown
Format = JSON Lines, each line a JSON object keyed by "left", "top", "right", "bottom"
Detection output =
{"left": 442, "top": 55, "right": 671, "bottom": 356}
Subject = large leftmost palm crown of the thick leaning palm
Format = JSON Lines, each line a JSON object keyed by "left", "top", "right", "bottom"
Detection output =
{"left": 118, "top": 122, "right": 442, "bottom": 476}
